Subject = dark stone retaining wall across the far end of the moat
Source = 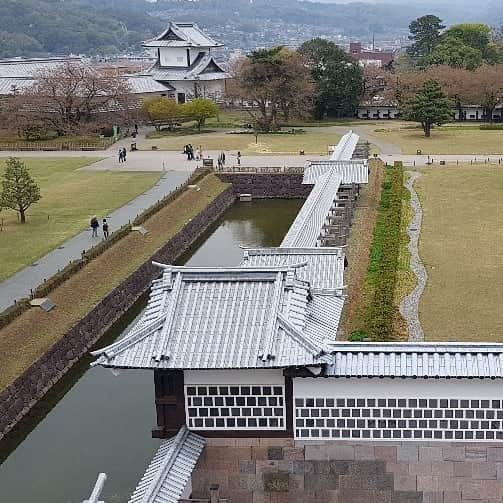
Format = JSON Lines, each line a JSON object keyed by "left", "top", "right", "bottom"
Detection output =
{"left": 218, "top": 173, "right": 313, "bottom": 199}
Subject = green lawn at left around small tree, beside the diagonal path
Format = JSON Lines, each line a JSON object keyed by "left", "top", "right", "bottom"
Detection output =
{"left": 0, "top": 157, "right": 162, "bottom": 280}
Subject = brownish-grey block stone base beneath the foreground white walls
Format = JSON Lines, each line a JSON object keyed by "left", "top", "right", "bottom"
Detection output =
{"left": 192, "top": 439, "right": 503, "bottom": 503}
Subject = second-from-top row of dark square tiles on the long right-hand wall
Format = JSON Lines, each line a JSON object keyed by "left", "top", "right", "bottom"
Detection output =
{"left": 297, "top": 408, "right": 503, "bottom": 419}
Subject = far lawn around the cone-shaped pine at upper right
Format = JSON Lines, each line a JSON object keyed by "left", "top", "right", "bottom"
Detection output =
{"left": 361, "top": 122, "right": 503, "bottom": 154}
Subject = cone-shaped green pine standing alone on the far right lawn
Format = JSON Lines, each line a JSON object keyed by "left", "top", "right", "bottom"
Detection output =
{"left": 403, "top": 80, "right": 452, "bottom": 138}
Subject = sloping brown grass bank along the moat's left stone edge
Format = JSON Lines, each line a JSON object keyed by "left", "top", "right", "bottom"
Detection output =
{"left": 0, "top": 175, "right": 228, "bottom": 389}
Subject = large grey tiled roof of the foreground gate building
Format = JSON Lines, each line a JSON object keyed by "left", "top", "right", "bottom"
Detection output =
{"left": 93, "top": 266, "right": 334, "bottom": 369}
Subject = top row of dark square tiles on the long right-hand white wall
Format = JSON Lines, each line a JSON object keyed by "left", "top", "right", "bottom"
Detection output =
{"left": 295, "top": 398, "right": 503, "bottom": 409}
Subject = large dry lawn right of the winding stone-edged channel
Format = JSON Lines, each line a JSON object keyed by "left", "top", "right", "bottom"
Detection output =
{"left": 416, "top": 165, "right": 503, "bottom": 342}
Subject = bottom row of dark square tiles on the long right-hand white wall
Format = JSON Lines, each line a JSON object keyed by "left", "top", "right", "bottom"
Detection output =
{"left": 295, "top": 428, "right": 503, "bottom": 440}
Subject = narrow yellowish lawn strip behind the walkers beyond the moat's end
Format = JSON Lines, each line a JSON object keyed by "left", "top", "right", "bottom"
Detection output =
{"left": 140, "top": 130, "right": 340, "bottom": 154}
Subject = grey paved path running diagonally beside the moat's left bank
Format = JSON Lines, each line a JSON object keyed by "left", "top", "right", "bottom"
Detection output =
{"left": 0, "top": 169, "right": 190, "bottom": 311}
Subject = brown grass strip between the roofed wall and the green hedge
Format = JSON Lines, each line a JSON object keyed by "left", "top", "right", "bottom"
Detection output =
{"left": 340, "top": 161, "right": 384, "bottom": 339}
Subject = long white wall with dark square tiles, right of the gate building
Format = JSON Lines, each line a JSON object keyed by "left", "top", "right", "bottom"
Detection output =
{"left": 293, "top": 378, "right": 503, "bottom": 442}
